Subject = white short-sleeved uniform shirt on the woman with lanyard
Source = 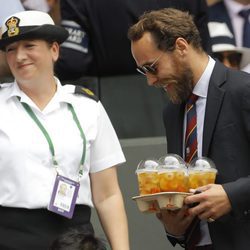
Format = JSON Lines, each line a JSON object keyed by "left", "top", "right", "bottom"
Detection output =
{"left": 0, "top": 80, "right": 125, "bottom": 208}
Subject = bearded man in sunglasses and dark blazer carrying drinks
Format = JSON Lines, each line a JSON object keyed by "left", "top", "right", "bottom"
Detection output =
{"left": 128, "top": 8, "right": 250, "bottom": 250}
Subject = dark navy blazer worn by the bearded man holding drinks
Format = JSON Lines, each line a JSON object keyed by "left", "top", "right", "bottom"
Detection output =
{"left": 163, "top": 62, "right": 250, "bottom": 250}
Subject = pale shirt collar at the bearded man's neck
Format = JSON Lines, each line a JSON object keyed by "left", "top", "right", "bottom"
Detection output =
{"left": 193, "top": 56, "right": 215, "bottom": 98}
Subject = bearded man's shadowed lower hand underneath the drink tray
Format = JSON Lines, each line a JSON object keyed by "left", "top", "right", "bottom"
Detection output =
{"left": 156, "top": 206, "right": 194, "bottom": 236}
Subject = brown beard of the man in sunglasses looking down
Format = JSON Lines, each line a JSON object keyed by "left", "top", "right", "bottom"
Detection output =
{"left": 157, "top": 61, "right": 194, "bottom": 104}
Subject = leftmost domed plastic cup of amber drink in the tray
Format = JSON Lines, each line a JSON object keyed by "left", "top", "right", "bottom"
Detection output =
{"left": 136, "top": 159, "right": 160, "bottom": 195}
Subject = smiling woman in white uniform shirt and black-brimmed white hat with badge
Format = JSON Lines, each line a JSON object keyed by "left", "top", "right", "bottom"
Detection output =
{"left": 0, "top": 11, "right": 129, "bottom": 250}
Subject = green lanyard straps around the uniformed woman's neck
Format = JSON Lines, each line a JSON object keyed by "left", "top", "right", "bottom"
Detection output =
{"left": 21, "top": 102, "right": 86, "bottom": 180}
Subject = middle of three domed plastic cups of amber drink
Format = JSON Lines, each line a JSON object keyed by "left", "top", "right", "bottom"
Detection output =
{"left": 158, "top": 154, "right": 189, "bottom": 192}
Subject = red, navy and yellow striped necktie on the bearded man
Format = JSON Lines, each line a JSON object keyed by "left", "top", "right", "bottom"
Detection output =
{"left": 185, "top": 94, "right": 198, "bottom": 163}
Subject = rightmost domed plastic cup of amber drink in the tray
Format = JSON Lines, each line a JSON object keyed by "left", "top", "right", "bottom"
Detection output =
{"left": 188, "top": 157, "right": 217, "bottom": 189}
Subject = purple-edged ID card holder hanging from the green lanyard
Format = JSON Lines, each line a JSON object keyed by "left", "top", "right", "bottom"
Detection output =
{"left": 48, "top": 175, "right": 80, "bottom": 219}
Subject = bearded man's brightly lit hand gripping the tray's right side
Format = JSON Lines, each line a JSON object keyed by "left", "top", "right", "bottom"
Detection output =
{"left": 184, "top": 184, "right": 232, "bottom": 220}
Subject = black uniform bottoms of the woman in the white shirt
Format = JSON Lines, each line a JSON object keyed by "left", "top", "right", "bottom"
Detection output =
{"left": 0, "top": 205, "right": 93, "bottom": 250}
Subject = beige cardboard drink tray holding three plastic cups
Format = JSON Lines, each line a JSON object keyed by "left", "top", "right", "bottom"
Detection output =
{"left": 132, "top": 192, "right": 191, "bottom": 213}
